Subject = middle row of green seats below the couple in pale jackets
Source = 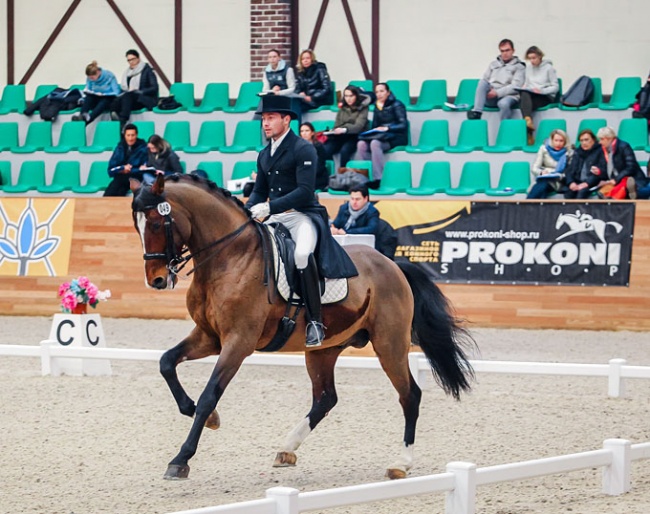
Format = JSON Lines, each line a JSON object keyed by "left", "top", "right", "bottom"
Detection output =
{"left": 404, "top": 118, "right": 650, "bottom": 154}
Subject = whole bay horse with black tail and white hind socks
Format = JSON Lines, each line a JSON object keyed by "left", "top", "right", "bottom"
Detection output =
{"left": 132, "top": 175, "right": 475, "bottom": 479}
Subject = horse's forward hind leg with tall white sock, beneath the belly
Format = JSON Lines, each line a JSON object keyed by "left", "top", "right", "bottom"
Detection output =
{"left": 273, "top": 348, "right": 342, "bottom": 467}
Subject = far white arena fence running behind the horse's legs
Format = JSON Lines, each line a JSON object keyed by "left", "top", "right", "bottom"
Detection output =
{"left": 0, "top": 340, "right": 650, "bottom": 398}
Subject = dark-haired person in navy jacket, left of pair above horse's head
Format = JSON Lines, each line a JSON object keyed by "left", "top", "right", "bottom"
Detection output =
{"left": 104, "top": 123, "right": 147, "bottom": 196}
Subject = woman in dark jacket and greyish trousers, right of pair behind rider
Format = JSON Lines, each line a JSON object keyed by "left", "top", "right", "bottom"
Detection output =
{"left": 357, "top": 82, "right": 408, "bottom": 183}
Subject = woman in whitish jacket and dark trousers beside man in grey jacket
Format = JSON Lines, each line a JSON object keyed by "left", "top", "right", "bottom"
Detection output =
{"left": 519, "top": 46, "right": 560, "bottom": 145}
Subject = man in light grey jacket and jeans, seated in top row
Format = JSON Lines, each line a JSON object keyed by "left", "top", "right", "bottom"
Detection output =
{"left": 467, "top": 39, "right": 526, "bottom": 120}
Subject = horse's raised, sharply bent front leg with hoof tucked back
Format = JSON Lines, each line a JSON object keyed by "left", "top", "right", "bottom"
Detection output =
{"left": 160, "top": 327, "right": 219, "bottom": 430}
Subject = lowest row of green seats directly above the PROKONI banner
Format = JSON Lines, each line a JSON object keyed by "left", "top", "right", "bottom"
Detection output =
{"left": 327, "top": 160, "right": 530, "bottom": 196}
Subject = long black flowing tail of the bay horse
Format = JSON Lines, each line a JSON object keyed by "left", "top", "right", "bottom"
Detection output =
{"left": 398, "top": 262, "right": 476, "bottom": 400}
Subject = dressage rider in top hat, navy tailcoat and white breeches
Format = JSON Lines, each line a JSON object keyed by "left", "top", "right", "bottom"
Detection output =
{"left": 246, "top": 95, "right": 357, "bottom": 346}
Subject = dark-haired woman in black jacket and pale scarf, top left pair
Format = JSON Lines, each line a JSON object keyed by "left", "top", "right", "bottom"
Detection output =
{"left": 111, "top": 50, "right": 158, "bottom": 125}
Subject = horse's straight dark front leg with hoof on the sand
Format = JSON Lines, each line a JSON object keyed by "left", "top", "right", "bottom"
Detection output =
{"left": 164, "top": 345, "right": 244, "bottom": 480}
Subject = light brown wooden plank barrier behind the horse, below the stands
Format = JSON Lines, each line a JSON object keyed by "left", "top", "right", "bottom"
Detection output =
{"left": 0, "top": 197, "right": 650, "bottom": 331}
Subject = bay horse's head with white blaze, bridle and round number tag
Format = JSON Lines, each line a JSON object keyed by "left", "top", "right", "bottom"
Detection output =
{"left": 131, "top": 175, "right": 186, "bottom": 289}
